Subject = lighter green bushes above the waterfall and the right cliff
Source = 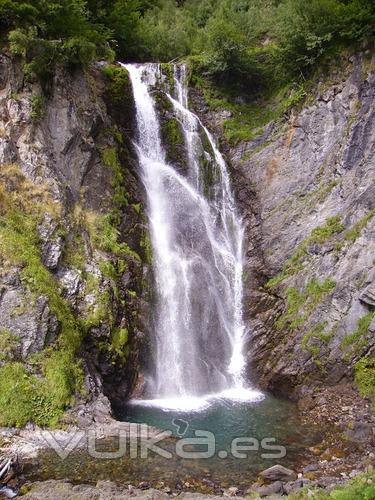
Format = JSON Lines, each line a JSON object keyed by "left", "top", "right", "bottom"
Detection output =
{"left": 139, "top": 0, "right": 375, "bottom": 90}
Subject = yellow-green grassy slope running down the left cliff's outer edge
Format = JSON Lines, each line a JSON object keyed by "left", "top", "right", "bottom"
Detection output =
{"left": 0, "top": 166, "right": 83, "bottom": 426}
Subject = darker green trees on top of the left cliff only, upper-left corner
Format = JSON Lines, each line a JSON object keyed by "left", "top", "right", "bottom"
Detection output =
{"left": 0, "top": 0, "right": 147, "bottom": 80}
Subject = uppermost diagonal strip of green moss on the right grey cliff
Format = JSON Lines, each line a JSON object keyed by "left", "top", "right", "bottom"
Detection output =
{"left": 265, "top": 216, "right": 344, "bottom": 288}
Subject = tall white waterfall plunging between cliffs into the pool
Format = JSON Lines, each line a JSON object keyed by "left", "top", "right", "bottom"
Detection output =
{"left": 124, "top": 64, "right": 259, "bottom": 408}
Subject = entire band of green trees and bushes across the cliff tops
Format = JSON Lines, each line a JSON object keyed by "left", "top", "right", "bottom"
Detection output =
{"left": 0, "top": 0, "right": 375, "bottom": 88}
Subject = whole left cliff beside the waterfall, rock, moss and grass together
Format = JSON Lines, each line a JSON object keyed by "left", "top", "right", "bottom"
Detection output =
{"left": 0, "top": 53, "right": 150, "bottom": 425}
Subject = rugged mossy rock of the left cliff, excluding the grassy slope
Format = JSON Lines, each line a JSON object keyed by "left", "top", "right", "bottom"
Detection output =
{"left": 0, "top": 53, "right": 148, "bottom": 420}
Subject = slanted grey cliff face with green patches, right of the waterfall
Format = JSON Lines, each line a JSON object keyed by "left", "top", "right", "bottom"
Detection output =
{"left": 229, "top": 53, "right": 375, "bottom": 404}
